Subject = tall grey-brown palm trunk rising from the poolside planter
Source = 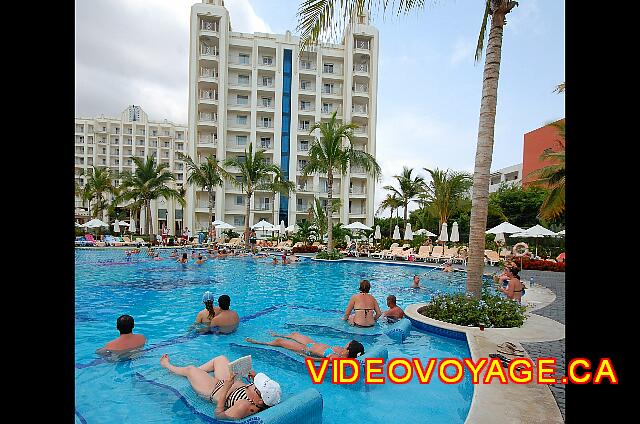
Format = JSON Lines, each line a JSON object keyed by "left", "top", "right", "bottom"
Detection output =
{"left": 467, "top": 2, "right": 513, "bottom": 299}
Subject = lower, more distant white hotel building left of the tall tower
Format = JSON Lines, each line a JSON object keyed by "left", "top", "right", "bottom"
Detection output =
{"left": 75, "top": 105, "right": 189, "bottom": 233}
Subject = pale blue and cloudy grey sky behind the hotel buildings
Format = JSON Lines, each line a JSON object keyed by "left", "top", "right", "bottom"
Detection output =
{"left": 75, "top": 0, "right": 565, "bottom": 216}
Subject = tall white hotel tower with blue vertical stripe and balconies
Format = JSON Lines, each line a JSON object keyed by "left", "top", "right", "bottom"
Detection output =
{"left": 186, "top": 0, "right": 378, "bottom": 230}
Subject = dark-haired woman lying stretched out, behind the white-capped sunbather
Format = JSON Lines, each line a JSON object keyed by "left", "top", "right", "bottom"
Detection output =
{"left": 245, "top": 331, "right": 364, "bottom": 360}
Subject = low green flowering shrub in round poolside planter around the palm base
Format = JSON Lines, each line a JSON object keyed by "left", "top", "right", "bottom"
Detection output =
{"left": 418, "top": 292, "right": 526, "bottom": 328}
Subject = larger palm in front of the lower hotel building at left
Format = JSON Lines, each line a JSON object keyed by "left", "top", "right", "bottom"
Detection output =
{"left": 117, "top": 156, "right": 186, "bottom": 240}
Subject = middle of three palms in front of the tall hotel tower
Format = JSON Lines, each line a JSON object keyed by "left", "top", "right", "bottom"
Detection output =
{"left": 223, "top": 144, "right": 282, "bottom": 249}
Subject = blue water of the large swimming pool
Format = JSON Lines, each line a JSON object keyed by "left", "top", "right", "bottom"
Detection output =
{"left": 75, "top": 249, "right": 473, "bottom": 424}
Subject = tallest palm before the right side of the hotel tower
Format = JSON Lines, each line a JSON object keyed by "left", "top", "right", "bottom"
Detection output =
{"left": 302, "top": 111, "right": 380, "bottom": 251}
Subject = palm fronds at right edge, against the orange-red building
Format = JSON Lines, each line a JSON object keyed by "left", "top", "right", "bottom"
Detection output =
{"left": 529, "top": 121, "right": 565, "bottom": 221}
